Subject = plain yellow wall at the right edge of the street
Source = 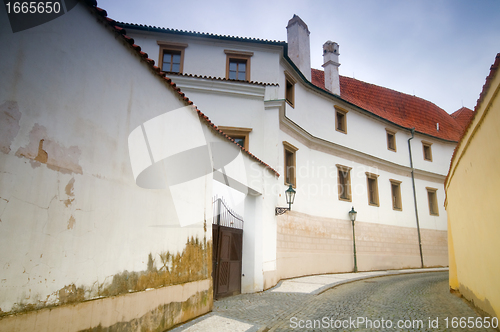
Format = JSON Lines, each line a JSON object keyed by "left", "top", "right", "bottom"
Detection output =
{"left": 445, "top": 54, "right": 500, "bottom": 317}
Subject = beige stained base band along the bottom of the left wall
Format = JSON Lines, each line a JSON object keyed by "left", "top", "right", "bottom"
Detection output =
{"left": 0, "top": 279, "right": 212, "bottom": 332}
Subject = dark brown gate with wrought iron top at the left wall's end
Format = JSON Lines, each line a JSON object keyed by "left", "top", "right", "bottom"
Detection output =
{"left": 212, "top": 198, "right": 243, "bottom": 299}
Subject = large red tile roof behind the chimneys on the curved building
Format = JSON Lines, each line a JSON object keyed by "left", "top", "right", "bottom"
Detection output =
{"left": 311, "top": 69, "right": 463, "bottom": 142}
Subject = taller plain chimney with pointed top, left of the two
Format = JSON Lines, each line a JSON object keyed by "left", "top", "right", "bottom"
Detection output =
{"left": 286, "top": 15, "right": 311, "bottom": 81}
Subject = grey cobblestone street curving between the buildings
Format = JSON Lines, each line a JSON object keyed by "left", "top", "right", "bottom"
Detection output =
{"left": 172, "top": 272, "right": 495, "bottom": 331}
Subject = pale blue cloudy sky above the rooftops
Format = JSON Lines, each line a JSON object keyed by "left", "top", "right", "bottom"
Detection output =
{"left": 98, "top": 0, "right": 500, "bottom": 113}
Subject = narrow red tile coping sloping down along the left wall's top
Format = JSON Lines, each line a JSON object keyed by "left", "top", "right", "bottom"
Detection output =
{"left": 85, "top": 0, "right": 279, "bottom": 176}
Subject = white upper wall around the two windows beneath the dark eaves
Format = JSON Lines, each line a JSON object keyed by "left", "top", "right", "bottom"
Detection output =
{"left": 127, "top": 28, "right": 280, "bottom": 83}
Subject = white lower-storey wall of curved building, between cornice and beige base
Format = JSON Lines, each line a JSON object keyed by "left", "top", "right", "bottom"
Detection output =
{"left": 278, "top": 132, "right": 446, "bottom": 230}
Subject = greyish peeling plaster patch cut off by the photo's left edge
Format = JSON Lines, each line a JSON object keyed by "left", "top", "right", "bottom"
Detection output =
{"left": 0, "top": 101, "right": 21, "bottom": 153}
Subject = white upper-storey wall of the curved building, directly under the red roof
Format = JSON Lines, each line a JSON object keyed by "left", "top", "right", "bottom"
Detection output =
{"left": 280, "top": 75, "right": 455, "bottom": 175}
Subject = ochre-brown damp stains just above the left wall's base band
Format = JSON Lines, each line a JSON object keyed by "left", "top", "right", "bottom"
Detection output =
{"left": 0, "top": 237, "right": 212, "bottom": 317}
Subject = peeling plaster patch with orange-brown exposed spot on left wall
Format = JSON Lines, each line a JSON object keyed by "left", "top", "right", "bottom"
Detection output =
{"left": 16, "top": 123, "right": 82, "bottom": 174}
